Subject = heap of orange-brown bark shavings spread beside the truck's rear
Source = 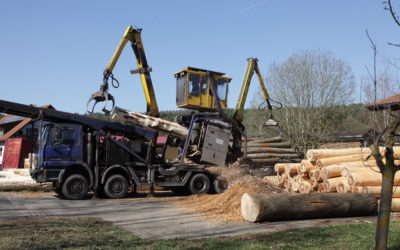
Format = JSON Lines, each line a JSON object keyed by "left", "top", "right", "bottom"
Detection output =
{"left": 175, "top": 167, "right": 284, "bottom": 222}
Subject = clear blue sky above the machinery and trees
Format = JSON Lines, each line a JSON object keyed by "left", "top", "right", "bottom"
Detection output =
{"left": 0, "top": 0, "right": 400, "bottom": 113}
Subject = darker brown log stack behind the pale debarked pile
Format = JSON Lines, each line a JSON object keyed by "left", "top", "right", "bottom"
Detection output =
{"left": 243, "top": 136, "right": 301, "bottom": 176}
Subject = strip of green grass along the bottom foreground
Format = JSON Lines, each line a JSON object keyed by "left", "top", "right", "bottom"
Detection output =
{"left": 0, "top": 218, "right": 400, "bottom": 249}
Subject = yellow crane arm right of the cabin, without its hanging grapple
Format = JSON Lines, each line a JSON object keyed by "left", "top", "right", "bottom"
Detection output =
{"left": 233, "top": 58, "right": 272, "bottom": 122}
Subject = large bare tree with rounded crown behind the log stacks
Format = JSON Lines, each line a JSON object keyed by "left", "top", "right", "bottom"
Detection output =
{"left": 255, "top": 50, "right": 355, "bottom": 152}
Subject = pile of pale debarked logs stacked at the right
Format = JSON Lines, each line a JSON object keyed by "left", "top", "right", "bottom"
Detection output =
{"left": 264, "top": 147, "right": 400, "bottom": 212}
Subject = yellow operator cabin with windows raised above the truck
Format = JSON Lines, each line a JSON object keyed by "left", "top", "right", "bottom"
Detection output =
{"left": 175, "top": 67, "right": 232, "bottom": 111}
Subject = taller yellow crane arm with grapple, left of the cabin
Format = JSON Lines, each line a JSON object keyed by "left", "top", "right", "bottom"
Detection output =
{"left": 87, "top": 26, "right": 159, "bottom": 117}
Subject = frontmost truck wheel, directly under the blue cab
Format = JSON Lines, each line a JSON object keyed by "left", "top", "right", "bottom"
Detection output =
{"left": 62, "top": 174, "right": 89, "bottom": 200}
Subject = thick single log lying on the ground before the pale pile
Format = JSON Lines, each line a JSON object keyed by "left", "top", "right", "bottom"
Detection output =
{"left": 241, "top": 193, "right": 378, "bottom": 222}
